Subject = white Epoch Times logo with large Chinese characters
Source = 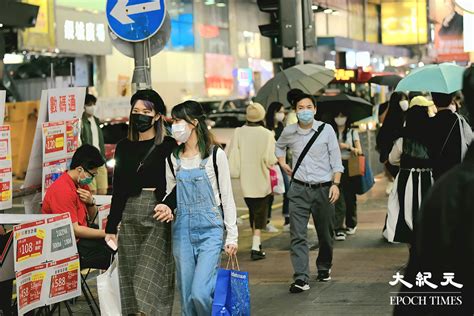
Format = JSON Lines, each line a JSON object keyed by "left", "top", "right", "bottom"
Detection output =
{"left": 388, "top": 272, "right": 463, "bottom": 306}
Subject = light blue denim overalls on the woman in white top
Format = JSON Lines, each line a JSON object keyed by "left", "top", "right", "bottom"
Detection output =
{"left": 173, "top": 158, "right": 224, "bottom": 316}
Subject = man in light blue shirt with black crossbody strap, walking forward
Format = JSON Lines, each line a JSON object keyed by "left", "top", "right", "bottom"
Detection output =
{"left": 276, "top": 91, "right": 344, "bottom": 293}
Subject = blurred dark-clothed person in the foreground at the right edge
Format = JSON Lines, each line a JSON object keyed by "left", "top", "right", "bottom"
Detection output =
{"left": 395, "top": 66, "right": 474, "bottom": 315}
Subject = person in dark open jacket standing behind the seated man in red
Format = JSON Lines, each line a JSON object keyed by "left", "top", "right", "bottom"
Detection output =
{"left": 81, "top": 94, "right": 108, "bottom": 195}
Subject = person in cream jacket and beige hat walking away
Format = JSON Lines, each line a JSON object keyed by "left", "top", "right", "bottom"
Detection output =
{"left": 229, "top": 103, "right": 277, "bottom": 260}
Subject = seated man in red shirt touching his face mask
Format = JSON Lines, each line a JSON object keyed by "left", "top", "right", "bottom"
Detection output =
{"left": 41, "top": 145, "right": 111, "bottom": 270}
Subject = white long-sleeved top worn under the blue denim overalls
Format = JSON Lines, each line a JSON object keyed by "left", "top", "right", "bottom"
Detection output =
{"left": 166, "top": 149, "right": 239, "bottom": 245}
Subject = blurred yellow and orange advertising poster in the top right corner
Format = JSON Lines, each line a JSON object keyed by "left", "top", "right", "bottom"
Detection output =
{"left": 430, "top": 0, "right": 469, "bottom": 62}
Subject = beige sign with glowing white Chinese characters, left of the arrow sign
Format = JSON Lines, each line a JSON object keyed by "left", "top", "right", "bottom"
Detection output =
{"left": 56, "top": 7, "right": 112, "bottom": 55}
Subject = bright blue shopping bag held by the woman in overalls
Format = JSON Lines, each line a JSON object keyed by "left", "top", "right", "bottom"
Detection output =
{"left": 211, "top": 256, "right": 250, "bottom": 316}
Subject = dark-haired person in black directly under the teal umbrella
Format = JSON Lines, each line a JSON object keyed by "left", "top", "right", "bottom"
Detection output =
{"left": 430, "top": 92, "right": 461, "bottom": 180}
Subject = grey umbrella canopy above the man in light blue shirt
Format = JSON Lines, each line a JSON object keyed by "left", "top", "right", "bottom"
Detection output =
{"left": 255, "top": 64, "right": 334, "bottom": 107}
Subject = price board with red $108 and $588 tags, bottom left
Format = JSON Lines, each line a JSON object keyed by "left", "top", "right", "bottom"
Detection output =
{"left": 13, "top": 213, "right": 81, "bottom": 315}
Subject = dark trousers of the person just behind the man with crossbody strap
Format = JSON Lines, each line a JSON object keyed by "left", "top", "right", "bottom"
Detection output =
{"left": 335, "top": 160, "right": 357, "bottom": 231}
